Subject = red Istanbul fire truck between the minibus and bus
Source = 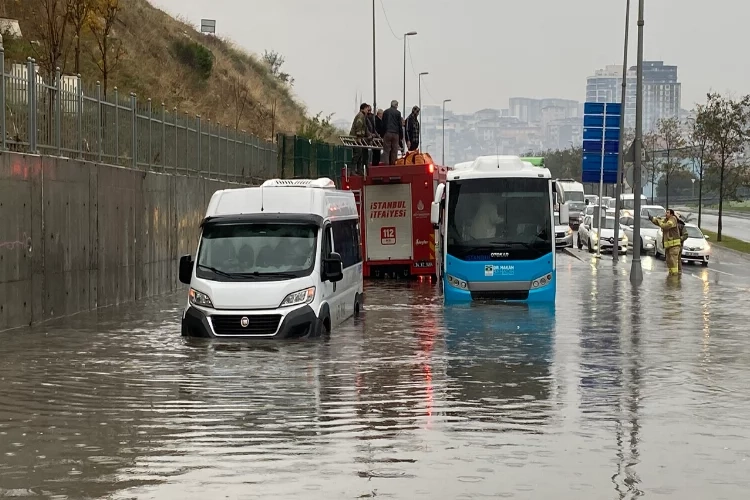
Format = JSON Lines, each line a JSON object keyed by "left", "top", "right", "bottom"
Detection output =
{"left": 341, "top": 153, "right": 448, "bottom": 278}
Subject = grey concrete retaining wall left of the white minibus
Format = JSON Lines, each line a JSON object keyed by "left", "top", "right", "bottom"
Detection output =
{"left": 0, "top": 153, "right": 240, "bottom": 331}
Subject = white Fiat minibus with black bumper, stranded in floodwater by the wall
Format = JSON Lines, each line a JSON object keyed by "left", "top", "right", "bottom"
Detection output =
{"left": 179, "top": 178, "right": 364, "bottom": 339}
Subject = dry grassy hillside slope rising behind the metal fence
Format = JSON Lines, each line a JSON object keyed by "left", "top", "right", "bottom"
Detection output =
{"left": 5, "top": 0, "right": 306, "bottom": 139}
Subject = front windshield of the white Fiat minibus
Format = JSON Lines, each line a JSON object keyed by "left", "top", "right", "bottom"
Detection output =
{"left": 196, "top": 223, "right": 318, "bottom": 281}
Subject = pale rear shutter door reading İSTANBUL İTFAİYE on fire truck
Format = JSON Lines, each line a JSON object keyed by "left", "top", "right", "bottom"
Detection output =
{"left": 365, "top": 184, "right": 414, "bottom": 260}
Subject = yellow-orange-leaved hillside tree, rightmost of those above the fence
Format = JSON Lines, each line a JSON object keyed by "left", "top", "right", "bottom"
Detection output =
{"left": 90, "top": 0, "right": 125, "bottom": 97}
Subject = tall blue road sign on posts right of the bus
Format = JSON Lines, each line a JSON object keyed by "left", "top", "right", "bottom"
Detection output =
{"left": 581, "top": 102, "right": 622, "bottom": 258}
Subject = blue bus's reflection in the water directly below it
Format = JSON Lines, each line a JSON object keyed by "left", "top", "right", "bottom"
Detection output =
{"left": 445, "top": 304, "right": 555, "bottom": 432}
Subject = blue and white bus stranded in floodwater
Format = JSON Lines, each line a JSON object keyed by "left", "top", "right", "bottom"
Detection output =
{"left": 430, "top": 155, "right": 569, "bottom": 303}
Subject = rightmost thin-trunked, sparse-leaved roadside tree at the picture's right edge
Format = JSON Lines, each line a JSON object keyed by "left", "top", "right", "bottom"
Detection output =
{"left": 696, "top": 93, "right": 750, "bottom": 241}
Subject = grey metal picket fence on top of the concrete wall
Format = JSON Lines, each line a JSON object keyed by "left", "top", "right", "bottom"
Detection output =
{"left": 0, "top": 52, "right": 279, "bottom": 184}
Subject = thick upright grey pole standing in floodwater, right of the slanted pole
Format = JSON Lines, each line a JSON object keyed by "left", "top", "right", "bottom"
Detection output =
{"left": 630, "top": 0, "right": 645, "bottom": 284}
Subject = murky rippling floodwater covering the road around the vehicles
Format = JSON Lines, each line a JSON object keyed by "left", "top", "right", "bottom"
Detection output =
{"left": 0, "top": 256, "right": 750, "bottom": 500}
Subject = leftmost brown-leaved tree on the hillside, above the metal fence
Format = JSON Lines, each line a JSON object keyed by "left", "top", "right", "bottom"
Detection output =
{"left": 26, "top": 0, "right": 68, "bottom": 76}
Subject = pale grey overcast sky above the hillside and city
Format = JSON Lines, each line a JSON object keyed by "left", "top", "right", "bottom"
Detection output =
{"left": 151, "top": 0, "right": 750, "bottom": 119}
